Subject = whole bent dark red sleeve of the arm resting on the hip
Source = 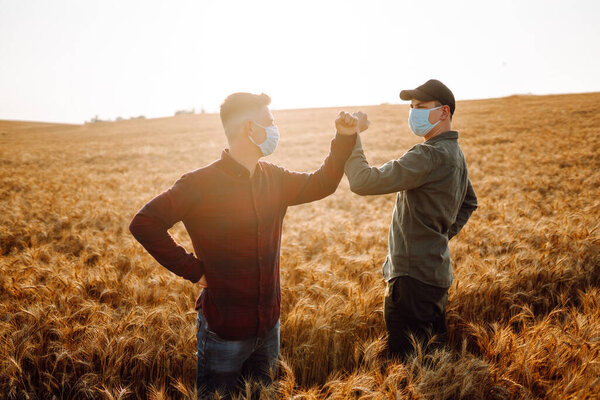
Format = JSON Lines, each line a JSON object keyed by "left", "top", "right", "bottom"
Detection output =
{"left": 129, "top": 174, "right": 203, "bottom": 283}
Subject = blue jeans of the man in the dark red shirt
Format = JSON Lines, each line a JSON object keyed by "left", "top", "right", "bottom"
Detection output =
{"left": 196, "top": 309, "right": 279, "bottom": 398}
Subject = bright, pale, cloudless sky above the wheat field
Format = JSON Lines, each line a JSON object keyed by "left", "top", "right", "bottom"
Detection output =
{"left": 0, "top": 0, "right": 600, "bottom": 123}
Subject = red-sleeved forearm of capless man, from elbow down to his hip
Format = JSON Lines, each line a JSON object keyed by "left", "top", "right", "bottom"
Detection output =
{"left": 129, "top": 211, "right": 203, "bottom": 283}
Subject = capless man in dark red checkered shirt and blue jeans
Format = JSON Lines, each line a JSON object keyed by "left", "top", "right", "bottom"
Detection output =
{"left": 129, "top": 93, "right": 368, "bottom": 395}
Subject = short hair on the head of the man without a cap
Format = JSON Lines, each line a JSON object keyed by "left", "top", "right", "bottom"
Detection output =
{"left": 220, "top": 92, "right": 271, "bottom": 141}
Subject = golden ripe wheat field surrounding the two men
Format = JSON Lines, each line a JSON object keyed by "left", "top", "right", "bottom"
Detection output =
{"left": 0, "top": 93, "right": 600, "bottom": 399}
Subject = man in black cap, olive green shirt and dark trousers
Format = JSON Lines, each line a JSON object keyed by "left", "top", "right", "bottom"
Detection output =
{"left": 345, "top": 79, "right": 477, "bottom": 358}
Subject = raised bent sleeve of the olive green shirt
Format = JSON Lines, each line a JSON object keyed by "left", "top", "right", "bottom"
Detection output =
{"left": 345, "top": 137, "right": 434, "bottom": 196}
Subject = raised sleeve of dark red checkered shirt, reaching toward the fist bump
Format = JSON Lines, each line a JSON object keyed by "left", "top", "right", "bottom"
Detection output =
{"left": 281, "top": 134, "right": 356, "bottom": 206}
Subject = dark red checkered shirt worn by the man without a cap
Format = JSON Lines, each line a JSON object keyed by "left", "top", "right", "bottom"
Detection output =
{"left": 129, "top": 134, "right": 356, "bottom": 340}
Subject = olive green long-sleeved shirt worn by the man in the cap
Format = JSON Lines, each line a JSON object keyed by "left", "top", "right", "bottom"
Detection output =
{"left": 345, "top": 131, "right": 477, "bottom": 287}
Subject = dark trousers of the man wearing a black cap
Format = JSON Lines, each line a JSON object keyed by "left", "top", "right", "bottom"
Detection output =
{"left": 384, "top": 276, "right": 448, "bottom": 359}
